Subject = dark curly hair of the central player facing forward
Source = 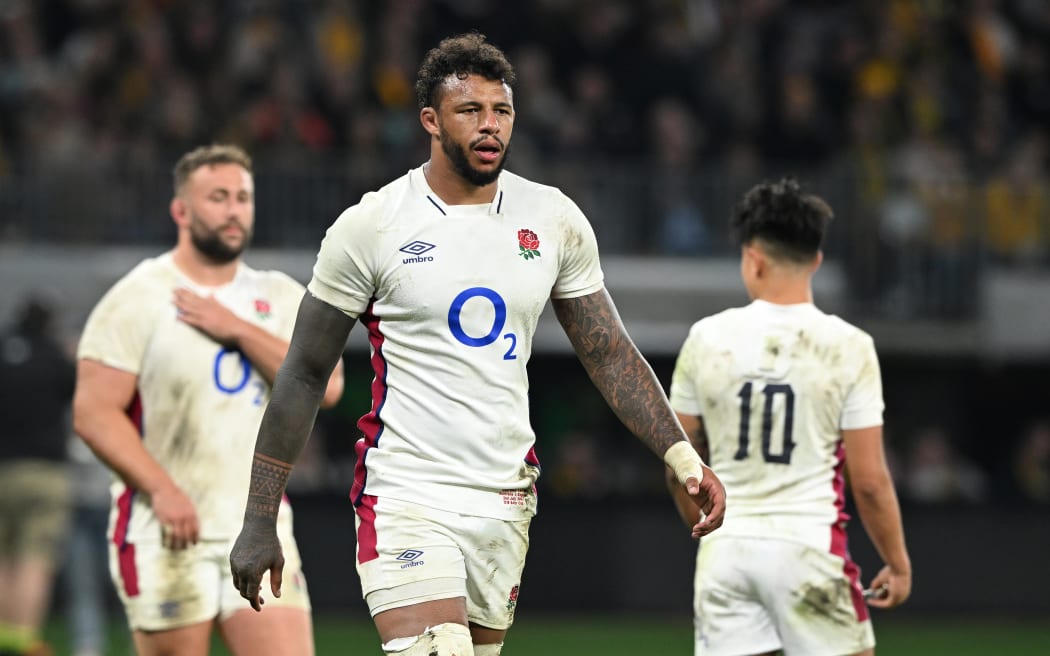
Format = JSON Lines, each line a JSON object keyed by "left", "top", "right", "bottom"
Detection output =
{"left": 416, "top": 31, "right": 515, "bottom": 109}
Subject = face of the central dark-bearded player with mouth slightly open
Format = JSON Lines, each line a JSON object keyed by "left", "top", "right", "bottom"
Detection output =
{"left": 436, "top": 75, "right": 515, "bottom": 187}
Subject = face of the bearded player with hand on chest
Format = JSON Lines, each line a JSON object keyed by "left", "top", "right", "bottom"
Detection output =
{"left": 184, "top": 164, "right": 255, "bottom": 263}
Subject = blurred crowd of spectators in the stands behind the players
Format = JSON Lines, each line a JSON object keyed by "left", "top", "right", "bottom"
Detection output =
{"left": 0, "top": 0, "right": 1050, "bottom": 289}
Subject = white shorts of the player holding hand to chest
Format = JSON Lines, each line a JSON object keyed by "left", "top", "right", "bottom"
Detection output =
{"left": 109, "top": 512, "right": 310, "bottom": 631}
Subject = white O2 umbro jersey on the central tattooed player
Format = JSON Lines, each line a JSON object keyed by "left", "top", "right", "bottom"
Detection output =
{"left": 308, "top": 167, "right": 603, "bottom": 519}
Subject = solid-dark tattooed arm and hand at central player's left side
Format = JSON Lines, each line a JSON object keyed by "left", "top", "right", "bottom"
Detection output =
{"left": 230, "top": 292, "right": 355, "bottom": 611}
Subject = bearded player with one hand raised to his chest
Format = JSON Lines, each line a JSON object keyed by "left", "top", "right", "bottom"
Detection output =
{"left": 74, "top": 145, "right": 342, "bottom": 656}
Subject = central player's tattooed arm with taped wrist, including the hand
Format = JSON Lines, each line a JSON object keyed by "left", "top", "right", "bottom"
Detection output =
{"left": 551, "top": 289, "right": 726, "bottom": 536}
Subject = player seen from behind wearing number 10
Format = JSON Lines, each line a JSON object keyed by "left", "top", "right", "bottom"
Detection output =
{"left": 671, "top": 179, "right": 911, "bottom": 656}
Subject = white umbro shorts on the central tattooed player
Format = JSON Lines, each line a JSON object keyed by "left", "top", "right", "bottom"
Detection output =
{"left": 356, "top": 495, "right": 531, "bottom": 630}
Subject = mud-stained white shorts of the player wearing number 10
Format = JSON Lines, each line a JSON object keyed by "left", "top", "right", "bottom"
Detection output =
{"left": 694, "top": 535, "right": 875, "bottom": 656}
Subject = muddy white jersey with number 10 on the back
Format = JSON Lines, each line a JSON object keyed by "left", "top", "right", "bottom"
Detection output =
{"left": 670, "top": 300, "right": 883, "bottom": 549}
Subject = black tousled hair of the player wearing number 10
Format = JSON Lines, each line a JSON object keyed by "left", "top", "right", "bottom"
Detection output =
{"left": 730, "top": 177, "right": 834, "bottom": 263}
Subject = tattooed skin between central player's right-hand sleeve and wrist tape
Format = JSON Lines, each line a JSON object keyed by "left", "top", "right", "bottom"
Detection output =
{"left": 552, "top": 291, "right": 685, "bottom": 456}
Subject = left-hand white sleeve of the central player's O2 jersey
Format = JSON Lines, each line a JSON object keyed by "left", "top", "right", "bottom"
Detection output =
{"left": 307, "top": 194, "right": 378, "bottom": 319}
